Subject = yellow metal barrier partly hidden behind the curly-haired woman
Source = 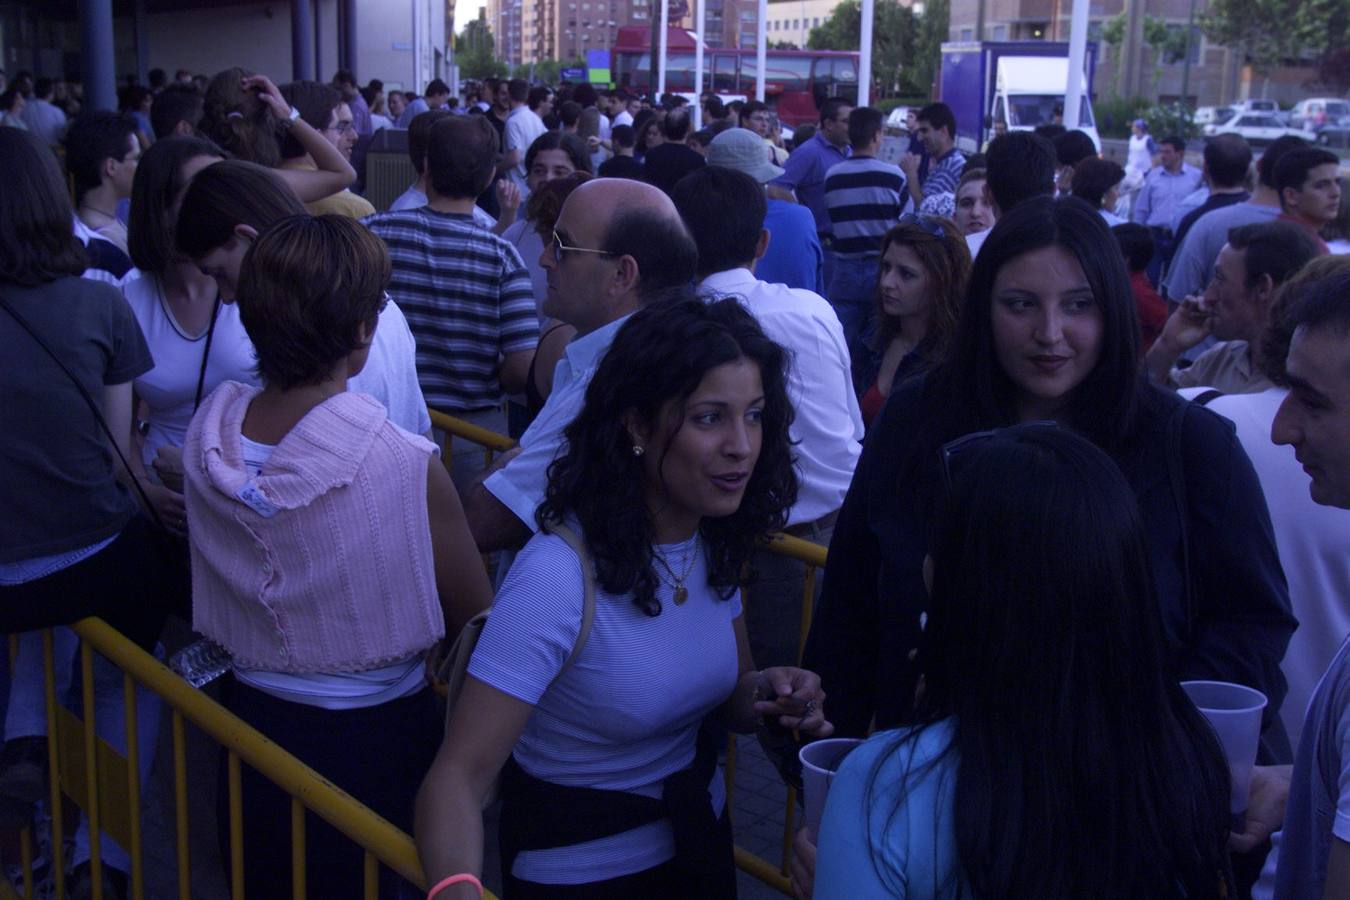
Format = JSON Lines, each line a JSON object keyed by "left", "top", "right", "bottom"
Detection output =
{"left": 431, "top": 410, "right": 826, "bottom": 896}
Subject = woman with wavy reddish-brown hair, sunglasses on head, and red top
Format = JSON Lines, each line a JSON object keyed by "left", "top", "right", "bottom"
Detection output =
{"left": 852, "top": 215, "right": 971, "bottom": 426}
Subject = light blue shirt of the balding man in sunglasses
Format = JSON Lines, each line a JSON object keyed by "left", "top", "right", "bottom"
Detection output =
{"left": 483, "top": 316, "right": 628, "bottom": 532}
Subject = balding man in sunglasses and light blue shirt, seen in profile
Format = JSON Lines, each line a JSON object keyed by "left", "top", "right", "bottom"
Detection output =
{"left": 464, "top": 178, "right": 698, "bottom": 553}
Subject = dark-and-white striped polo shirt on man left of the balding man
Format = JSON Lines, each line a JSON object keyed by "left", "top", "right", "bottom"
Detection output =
{"left": 362, "top": 206, "right": 539, "bottom": 413}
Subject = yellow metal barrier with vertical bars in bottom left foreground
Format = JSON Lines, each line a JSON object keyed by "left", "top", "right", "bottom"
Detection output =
{"left": 13, "top": 619, "right": 502, "bottom": 900}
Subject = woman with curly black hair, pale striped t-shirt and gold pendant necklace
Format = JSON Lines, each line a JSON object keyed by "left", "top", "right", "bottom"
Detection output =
{"left": 416, "top": 294, "right": 833, "bottom": 900}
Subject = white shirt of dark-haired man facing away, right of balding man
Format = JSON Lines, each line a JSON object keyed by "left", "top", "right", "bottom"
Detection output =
{"left": 698, "top": 269, "right": 863, "bottom": 525}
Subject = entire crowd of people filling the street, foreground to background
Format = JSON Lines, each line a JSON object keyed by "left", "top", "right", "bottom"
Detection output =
{"left": 0, "top": 58, "right": 1350, "bottom": 900}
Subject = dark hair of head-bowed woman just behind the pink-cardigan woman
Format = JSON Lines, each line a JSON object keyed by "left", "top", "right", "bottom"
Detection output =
{"left": 174, "top": 159, "right": 305, "bottom": 259}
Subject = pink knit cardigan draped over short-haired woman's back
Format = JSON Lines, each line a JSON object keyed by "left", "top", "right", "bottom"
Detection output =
{"left": 184, "top": 382, "right": 446, "bottom": 673}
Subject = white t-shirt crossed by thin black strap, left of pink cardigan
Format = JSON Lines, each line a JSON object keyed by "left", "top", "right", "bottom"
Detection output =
{"left": 122, "top": 275, "right": 261, "bottom": 478}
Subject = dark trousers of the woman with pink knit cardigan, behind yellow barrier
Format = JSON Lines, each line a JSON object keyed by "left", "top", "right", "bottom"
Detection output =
{"left": 217, "top": 677, "right": 440, "bottom": 900}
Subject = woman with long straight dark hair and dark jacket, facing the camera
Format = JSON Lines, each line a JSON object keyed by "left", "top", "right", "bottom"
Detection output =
{"left": 806, "top": 198, "right": 1296, "bottom": 761}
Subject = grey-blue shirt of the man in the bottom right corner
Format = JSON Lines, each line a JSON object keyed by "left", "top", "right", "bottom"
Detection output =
{"left": 1274, "top": 641, "right": 1350, "bottom": 900}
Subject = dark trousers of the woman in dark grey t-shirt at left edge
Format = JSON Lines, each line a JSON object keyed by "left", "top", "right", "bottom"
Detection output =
{"left": 0, "top": 515, "right": 177, "bottom": 652}
